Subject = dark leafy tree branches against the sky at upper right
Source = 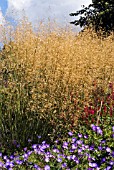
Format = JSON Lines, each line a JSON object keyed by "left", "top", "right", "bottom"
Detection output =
{"left": 70, "top": 0, "right": 114, "bottom": 35}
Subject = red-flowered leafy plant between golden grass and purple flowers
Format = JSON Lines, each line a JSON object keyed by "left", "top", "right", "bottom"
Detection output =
{"left": 78, "top": 83, "right": 114, "bottom": 125}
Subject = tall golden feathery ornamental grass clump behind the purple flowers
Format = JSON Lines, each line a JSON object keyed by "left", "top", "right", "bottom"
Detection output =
{"left": 0, "top": 16, "right": 114, "bottom": 154}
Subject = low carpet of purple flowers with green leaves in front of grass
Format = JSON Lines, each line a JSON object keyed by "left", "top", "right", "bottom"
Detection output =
{"left": 0, "top": 124, "right": 114, "bottom": 170}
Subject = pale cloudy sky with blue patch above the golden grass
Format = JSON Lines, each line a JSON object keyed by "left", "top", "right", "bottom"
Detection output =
{"left": 0, "top": 0, "right": 92, "bottom": 28}
